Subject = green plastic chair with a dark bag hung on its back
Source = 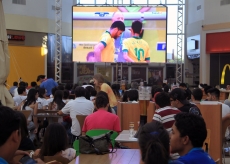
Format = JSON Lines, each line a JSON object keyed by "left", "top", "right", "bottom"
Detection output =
{"left": 73, "top": 129, "right": 118, "bottom": 156}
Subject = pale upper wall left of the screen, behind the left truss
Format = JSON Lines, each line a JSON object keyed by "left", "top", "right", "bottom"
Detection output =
{"left": 2, "top": 0, "right": 73, "bottom": 36}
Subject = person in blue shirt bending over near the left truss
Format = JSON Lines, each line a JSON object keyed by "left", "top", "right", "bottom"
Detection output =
{"left": 37, "top": 75, "right": 58, "bottom": 96}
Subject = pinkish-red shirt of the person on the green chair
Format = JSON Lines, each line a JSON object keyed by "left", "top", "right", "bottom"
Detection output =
{"left": 82, "top": 109, "right": 121, "bottom": 132}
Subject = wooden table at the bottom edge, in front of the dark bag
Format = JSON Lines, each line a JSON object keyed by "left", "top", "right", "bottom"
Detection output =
{"left": 69, "top": 149, "right": 141, "bottom": 164}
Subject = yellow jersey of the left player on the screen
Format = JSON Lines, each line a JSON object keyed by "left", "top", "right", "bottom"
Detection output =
{"left": 100, "top": 31, "right": 115, "bottom": 62}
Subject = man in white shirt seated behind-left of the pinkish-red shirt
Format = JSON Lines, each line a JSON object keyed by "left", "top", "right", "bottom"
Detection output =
{"left": 58, "top": 87, "right": 94, "bottom": 143}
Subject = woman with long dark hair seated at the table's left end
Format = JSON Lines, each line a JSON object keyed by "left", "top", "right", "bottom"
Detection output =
{"left": 22, "top": 89, "right": 38, "bottom": 136}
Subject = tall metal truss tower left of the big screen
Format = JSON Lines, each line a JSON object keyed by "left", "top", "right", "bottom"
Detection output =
{"left": 55, "top": 0, "right": 62, "bottom": 83}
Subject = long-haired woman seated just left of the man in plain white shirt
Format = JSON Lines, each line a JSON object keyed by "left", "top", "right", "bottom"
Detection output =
{"left": 49, "top": 90, "right": 65, "bottom": 110}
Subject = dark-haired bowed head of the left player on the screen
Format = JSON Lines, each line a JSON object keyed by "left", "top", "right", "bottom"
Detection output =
{"left": 110, "top": 21, "right": 125, "bottom": 39}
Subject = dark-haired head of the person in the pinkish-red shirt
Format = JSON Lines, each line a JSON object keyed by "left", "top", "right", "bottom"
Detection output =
{"left": 95, "top": 91, "right": 109, "bottom": 110}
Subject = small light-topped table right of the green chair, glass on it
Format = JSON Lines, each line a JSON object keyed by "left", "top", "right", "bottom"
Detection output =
{"left": 115, "top": 130, "right": 139, "bottom": 149}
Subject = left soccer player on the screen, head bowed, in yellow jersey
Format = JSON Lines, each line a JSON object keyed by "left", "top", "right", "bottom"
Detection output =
{"left": 94, "top": 21, "right": 125, "bottom": 62}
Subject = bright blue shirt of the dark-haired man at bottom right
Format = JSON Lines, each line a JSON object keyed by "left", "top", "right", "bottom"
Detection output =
{"left": 177, "top": 148, "right": 215, "bottom": 164}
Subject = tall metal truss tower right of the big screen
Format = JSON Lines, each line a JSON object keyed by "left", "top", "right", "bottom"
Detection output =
{"left": 176, "top": 0, "right": 184, "bottom": 84}
